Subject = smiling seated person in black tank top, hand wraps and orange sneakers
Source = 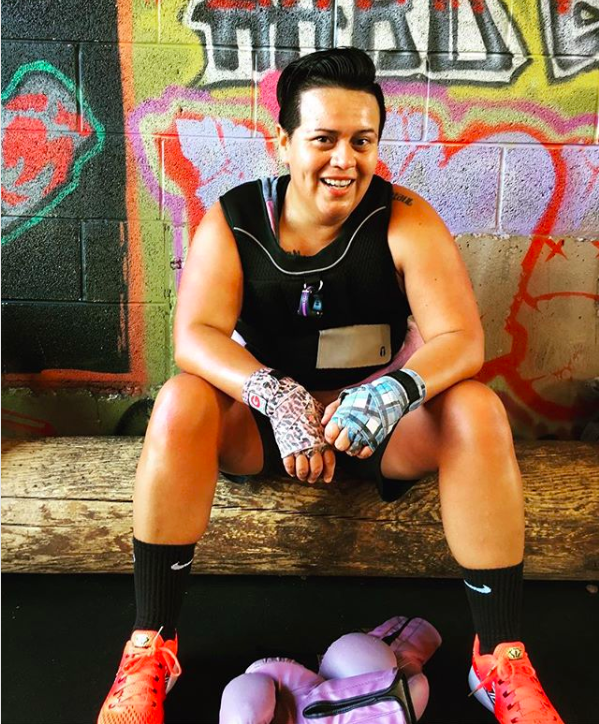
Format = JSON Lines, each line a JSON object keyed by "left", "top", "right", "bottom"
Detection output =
{"left": 99, "top": 48, "right": 561, "bottom": 724}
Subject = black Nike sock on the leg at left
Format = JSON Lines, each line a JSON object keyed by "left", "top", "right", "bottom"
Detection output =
{"left": 133, "top": 538, "right": 195, "bottom": 641}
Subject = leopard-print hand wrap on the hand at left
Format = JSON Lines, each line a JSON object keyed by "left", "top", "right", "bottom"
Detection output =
{"left": 243, "top": 367, "right": 328, "bottom": 458}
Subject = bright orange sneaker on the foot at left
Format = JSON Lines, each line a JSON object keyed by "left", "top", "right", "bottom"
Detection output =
{"left": 98, "top": 631, "right": 181, "bottom": 724}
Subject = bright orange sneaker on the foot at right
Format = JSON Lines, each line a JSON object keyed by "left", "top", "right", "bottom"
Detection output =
{"left": 468, "top": 636, "right": 564, "bottom": 724}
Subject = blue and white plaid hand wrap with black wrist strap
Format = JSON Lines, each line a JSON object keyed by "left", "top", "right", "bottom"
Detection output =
{"left": 331, "top": 369, "right": 426, "bottom": 453}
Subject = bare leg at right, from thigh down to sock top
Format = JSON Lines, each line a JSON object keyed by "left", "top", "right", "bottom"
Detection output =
{"left": 382, "top": 380, "right": 524, "bottom": 569}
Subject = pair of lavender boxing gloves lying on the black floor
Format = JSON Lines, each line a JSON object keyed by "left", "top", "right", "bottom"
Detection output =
{"left": 219, "top": 616, "right": 441, "bottom": 724}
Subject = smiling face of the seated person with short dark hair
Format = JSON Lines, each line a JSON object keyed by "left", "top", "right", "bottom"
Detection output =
{"left": 277, "top": 88, "right": 380, "bottom": 225}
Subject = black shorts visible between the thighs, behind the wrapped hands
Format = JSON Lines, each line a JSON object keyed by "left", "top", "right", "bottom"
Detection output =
{"left": 222, "top": 408, "right": 418, "bottom": 503}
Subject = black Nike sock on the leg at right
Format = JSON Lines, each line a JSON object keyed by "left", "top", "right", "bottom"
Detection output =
{"left": 462, "top": 563, "right": 524, "bottom": 654}
